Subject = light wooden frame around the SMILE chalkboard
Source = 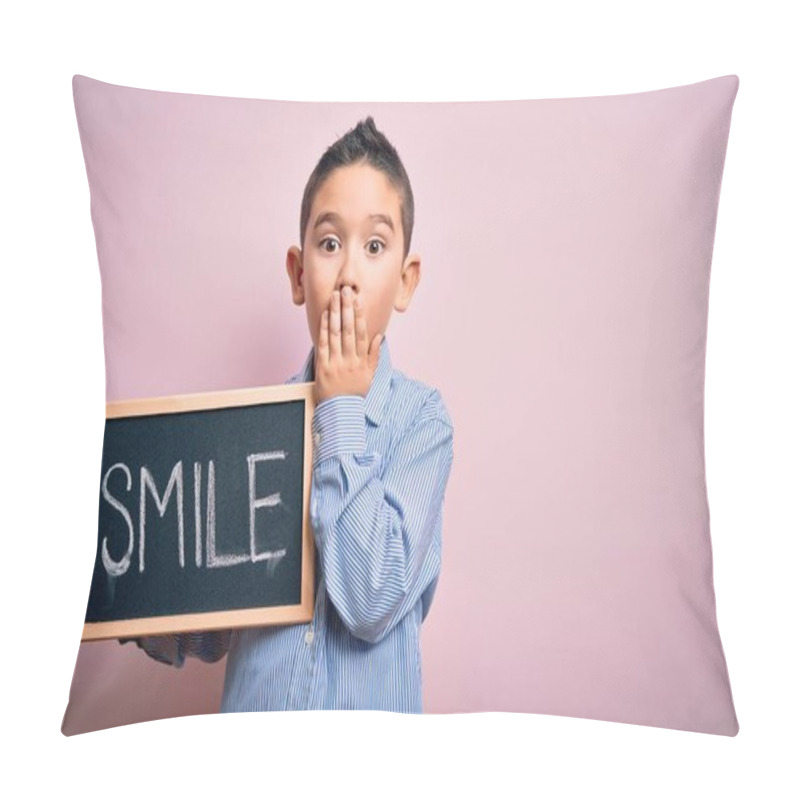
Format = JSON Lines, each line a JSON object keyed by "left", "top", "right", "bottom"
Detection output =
{"left": 81, "top": 383, "right": 315, "bottom": 641}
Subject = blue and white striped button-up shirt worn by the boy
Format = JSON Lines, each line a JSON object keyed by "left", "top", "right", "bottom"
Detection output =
{"left": 131, "top": 337, "right": 453, "bottom": 713}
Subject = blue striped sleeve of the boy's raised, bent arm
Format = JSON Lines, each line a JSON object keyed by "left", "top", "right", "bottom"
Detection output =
{"left": 310, "top": 390, "right": 453, "bottom": 642}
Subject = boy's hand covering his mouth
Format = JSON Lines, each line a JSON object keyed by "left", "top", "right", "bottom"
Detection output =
{"left": 314, "top": 286, "right": 383, "bottom": 404}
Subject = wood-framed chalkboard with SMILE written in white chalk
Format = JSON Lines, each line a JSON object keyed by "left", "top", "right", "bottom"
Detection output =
{"left": 82, "top": 383, "right": 314, "bottom": 640}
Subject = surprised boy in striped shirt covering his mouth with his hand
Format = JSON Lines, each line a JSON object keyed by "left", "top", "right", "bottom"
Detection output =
{"left": 131, "top": 117, "right": 453, "bottom": 713}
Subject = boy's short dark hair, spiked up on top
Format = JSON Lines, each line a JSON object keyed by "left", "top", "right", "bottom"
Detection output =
{"left": 300, "top": 116, "right": 414, "bottom": 260}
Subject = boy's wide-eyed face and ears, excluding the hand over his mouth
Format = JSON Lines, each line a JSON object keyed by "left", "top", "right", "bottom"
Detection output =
{"left": 286, "top": 164, "right": 420, "bottom": 348}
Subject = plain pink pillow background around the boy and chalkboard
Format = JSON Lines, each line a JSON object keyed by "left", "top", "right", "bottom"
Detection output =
{"left": 62, "top": 75, "right": 739, "bottom": 736}
